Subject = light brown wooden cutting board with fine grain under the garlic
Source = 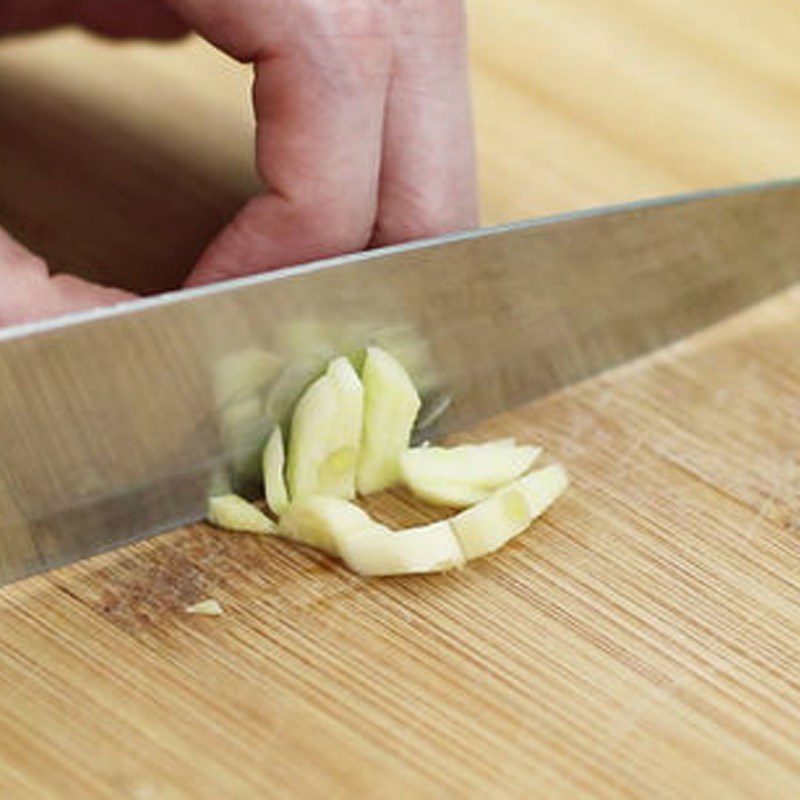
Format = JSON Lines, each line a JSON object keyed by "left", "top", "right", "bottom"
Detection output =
{"left": 0, "top": 0, "right": 800, "bottom": 800}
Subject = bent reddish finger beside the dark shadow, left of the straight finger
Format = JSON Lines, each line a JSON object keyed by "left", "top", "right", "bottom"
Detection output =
{"left": 173, "top": 0, "right": 391, "bottom": 285}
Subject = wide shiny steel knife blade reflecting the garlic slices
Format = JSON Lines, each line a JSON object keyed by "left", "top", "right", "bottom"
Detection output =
{"left": 0, "top": 180, "right": 800, "bottom": 584}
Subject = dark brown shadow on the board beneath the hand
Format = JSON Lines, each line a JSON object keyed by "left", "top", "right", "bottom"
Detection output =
{"left": 0, "top": 62, "right": 257, "bottom": 293}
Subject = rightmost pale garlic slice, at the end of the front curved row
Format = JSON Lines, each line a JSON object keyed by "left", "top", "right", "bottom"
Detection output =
{"left": 450, "top": 464, "right": 569, "bottom": 560}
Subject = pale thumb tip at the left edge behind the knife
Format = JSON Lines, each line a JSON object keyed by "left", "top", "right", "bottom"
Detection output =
{"left": 0, "top": 230, "right": 135, "bottom": 327}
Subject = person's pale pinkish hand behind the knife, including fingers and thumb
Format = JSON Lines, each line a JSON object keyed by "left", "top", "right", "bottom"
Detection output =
{"left": 0, "top": 0, "right": 478, "bottom": 326}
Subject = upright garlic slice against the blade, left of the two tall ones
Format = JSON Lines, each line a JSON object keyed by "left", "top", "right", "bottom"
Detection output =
{"left": 286, "top": 357, "right": 364, "bottom": 500}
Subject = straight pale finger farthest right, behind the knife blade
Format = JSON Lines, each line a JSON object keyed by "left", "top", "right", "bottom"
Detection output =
{"left": 372, "top": 0, "right": 478, "bottom": 245}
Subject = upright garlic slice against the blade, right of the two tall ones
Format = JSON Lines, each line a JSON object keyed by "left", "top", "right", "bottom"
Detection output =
{"left": 357, "top": 347, "right": 421, "bottom": 494}
